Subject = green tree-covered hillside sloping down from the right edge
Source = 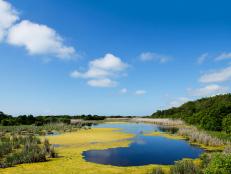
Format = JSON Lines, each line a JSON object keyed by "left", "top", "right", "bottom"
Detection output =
{"left": 151, "top": 94, "right": 231, "bottom": 133}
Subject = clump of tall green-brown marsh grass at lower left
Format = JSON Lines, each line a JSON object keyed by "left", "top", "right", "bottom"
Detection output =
{"left": 0, "top": 135, "right": 57, "bottom": 168}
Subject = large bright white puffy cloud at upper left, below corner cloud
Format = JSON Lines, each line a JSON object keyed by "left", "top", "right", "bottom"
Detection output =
{"left": 7, "top": 20, "right": 75, "bottom": 58}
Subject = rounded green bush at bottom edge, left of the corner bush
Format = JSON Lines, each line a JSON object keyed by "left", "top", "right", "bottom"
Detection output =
{"left": 170, "top": 159, "right": 202, "bottom": 174}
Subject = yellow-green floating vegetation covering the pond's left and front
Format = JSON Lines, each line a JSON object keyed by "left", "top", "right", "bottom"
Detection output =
{"left": 0, "top": 128, "right": 170, "bottom": 174}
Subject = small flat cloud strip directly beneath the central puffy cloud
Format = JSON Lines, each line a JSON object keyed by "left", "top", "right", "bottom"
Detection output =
{"left": 87, "top": 78, "right": 117, "bottom": 88}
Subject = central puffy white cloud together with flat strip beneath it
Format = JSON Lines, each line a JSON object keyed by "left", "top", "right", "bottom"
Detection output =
{"left": 70, "top": 53, "right": 128, "bottom": 87}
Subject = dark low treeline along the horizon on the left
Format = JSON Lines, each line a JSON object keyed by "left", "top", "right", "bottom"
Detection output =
{"left": 0, "top": 112, "right": 106, "bottom": 126}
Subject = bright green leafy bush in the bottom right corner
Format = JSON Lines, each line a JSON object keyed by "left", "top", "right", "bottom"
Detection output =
{"left": 204, "top": 153, "right": 231, "bottom": 174}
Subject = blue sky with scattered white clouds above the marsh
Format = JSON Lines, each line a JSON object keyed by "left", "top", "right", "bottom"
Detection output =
{"left": 0, "top": 0, "right": 231, "bottom": 115}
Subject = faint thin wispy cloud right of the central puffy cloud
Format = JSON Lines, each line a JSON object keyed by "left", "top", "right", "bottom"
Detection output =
{"left": 139, "top": 52, "right": 171, "bottom": 63}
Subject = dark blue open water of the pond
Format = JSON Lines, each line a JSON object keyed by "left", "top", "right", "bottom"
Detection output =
{"left": 83, "top": 123, "right": 203, "bottom": 166}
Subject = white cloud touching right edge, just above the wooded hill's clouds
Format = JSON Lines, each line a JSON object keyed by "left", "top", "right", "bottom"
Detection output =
{"left": 199, "top": 66, "right": 231, "bottom": 83}
